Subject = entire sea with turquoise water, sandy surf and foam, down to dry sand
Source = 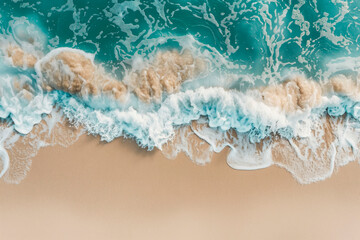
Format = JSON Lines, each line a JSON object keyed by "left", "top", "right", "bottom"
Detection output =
{"left": 0, "top": 0, "right": 360, "bottom": 183}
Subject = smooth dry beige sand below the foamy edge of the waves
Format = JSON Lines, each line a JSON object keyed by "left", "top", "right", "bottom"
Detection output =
{"left": 0, "top": 136, "right": 360, "bottom": 240}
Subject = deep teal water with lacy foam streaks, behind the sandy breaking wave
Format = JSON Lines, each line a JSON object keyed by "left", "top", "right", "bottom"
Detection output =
{"left": 1, "top": 0, "right": 360, "bottom": 81}
